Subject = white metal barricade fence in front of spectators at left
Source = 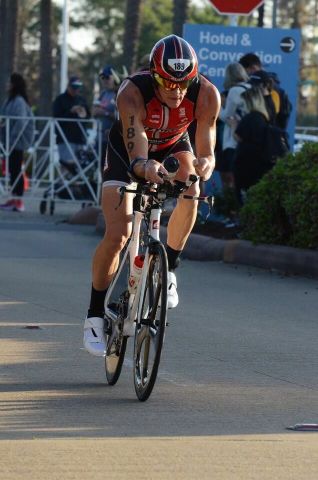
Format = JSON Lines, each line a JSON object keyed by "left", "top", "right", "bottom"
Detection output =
{"left": 0, "top": 116, "right": 102, "bottom": 213}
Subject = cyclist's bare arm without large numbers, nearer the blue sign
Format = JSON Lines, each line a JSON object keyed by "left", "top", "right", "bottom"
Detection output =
{"left": 194, "top": 79, "right": 221, "bottom": 180}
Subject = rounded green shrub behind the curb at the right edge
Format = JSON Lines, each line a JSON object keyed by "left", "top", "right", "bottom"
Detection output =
{"left": 240, "top": 143, "right": 318, "bottom": 248}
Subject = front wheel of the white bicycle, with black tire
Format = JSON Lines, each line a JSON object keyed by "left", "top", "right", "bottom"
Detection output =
{"left": 134, "top": 243, "right": 168, "bottom": 401}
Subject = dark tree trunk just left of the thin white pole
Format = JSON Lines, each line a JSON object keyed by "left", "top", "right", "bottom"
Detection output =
{"left": 38, "top": 0, "right": 53, "bottom": 116}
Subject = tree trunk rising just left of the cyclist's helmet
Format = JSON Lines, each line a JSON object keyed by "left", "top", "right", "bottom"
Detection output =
{"left": 123, "top": 0, "right": 142, "bottom": 73}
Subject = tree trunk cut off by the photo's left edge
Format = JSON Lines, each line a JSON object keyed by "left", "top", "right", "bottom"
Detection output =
{"left": 0, "top": 0, "right": 19, "bottom": 104}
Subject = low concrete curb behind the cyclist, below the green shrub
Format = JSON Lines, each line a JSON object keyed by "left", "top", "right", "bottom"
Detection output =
{"left": 73, "top": 211, "right": 318, "bottom": 278}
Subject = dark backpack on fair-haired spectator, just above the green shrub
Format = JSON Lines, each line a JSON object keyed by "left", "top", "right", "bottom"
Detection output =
{"left": 264, "top": 123, "right": 289, "bottom": 165}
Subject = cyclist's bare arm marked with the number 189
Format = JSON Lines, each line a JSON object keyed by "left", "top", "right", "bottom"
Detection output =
{"left": 117, "top": 80, "right": 167, "bottom": 183}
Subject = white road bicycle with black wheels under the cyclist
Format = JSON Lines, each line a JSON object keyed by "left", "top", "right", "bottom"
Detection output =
{"left": 105, "top": 156, "right": 210, "bottom": 401}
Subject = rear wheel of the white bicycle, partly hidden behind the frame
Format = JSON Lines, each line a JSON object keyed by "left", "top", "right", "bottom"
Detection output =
{"left": 105, "top": 245, "right": 129, "bottom": 385}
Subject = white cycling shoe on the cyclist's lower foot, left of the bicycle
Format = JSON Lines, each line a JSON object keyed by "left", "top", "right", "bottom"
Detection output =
{"left": 83, "top": 317, "right": 106, "bottom": 357}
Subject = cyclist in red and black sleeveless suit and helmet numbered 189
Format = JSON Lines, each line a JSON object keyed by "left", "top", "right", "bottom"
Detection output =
{"left": 83, "top": 35, "right": 220, "bottom": 356}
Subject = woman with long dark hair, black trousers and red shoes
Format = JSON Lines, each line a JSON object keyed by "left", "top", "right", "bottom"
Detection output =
{"left": 0, "top": 73, "right": 34, "bottom": 212}
